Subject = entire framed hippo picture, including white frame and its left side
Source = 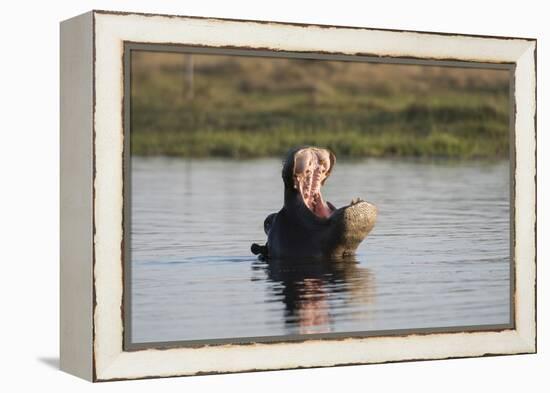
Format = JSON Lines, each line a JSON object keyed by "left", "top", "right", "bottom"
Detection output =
{"left": 60, "top": 11, "right": 536, "bottom": 381}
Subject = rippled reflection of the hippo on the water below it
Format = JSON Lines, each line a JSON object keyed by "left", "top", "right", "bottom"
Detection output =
{"left": 255, "top": 256, "right": 375, "bottom": 334}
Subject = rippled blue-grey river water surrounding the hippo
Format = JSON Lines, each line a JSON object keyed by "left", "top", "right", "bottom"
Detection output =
{"left": 131, "top": 157, "right": 510, "bottom": 343}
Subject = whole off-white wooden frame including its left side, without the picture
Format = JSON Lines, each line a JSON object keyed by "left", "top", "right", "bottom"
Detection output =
{"left": 60, "top": 11, "right": 536, "bottom": 381}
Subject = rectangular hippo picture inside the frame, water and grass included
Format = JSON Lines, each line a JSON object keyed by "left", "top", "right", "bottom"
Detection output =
{"left": 125, "top": 50, "right": 513, "bottom": 346}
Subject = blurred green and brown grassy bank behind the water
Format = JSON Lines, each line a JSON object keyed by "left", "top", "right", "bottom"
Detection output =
{"left": 131, "top": 52, "right": 509, "bottom": 158}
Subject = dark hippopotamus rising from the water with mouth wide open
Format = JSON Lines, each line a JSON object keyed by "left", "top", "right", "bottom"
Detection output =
{"left": 251, "top": 146, "right": 378, "bottom": 258}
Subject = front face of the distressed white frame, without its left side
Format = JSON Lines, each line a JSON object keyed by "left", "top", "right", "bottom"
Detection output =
{"left": 62, "top": 12, "right": 536, "bottom": 381}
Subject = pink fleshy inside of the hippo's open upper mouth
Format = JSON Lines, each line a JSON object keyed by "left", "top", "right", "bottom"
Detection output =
{"left": 294, "top": 148, "right": 334, "bottom": 218}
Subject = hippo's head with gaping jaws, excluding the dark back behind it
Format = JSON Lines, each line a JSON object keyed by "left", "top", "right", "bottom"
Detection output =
{"left": 282, "top": 146, "right": 377, "bottom": 256}
